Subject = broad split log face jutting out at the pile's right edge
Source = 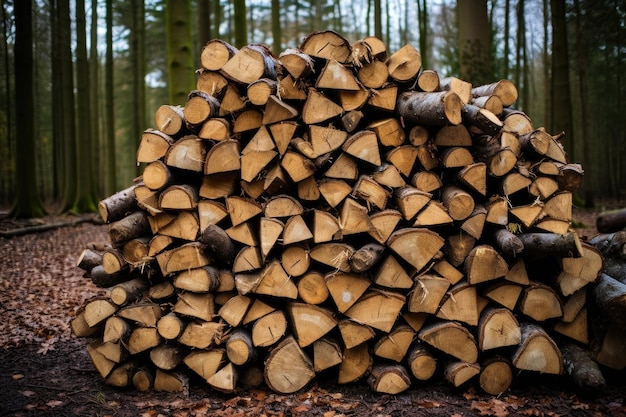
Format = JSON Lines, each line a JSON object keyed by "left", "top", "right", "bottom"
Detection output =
{"left": 556, "top": 243, "right": 604, "bottom": 297}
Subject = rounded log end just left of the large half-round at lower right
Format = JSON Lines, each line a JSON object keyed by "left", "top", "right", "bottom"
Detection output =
{"left": 477, "top": 307, "right": 522, "bottom": 352}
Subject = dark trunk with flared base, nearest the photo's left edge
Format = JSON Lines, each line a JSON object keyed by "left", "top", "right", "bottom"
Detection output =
{"left": 10, "top": 1, "right": 46, "bottom": 217}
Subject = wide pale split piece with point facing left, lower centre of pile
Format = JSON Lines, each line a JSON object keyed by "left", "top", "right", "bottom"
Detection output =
{"left": 345, "top": 289, "right": 405, "bottom": 332}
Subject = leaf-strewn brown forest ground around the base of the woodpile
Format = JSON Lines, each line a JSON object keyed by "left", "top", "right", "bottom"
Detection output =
{"left": 0, "top": 202, "right": 626, "bottom": 417}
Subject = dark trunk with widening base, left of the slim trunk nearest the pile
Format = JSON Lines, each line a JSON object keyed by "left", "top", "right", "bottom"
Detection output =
{"left": 72, "top": 0, "right": 96, "bottom": 213}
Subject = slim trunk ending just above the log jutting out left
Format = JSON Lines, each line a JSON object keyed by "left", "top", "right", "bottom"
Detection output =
{"left": 104, "top": 1, "right": 117, "bottom": 195}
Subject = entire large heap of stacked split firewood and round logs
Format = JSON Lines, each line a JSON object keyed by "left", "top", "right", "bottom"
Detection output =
{"left": 72, "top": 31, "right": 604, "bottom": 394}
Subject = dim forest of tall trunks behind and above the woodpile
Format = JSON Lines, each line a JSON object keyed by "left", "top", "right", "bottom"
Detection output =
{"left": 0, "top": 0, "right": 626, "bottom": 217}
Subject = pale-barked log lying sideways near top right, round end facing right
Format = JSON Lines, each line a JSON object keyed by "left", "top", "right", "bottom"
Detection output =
{"left": 396, "top": 91, "right": 463, "bottom": 126}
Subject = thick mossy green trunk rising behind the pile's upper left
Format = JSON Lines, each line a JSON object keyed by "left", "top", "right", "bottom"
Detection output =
{"left": 165, "top": 0, "right": 195, "bottom": 105}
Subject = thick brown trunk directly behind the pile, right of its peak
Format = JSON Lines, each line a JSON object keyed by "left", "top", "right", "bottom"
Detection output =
{"left": 457, "top": 0, "right": 493, "bottom": 85}
